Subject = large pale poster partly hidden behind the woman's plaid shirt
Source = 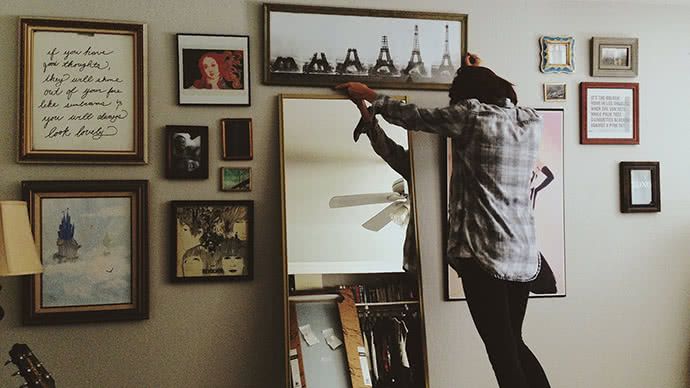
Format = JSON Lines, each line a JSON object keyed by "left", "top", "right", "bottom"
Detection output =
{"left": 444, "top": 108, "right": 566, "bottom": 300}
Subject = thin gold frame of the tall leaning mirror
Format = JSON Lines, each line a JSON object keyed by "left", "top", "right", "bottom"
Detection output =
{"left": 278, "top": 94, "right": 429, "bottom": 388}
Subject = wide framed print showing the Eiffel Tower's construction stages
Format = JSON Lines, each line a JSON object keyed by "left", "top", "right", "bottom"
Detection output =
{"left": 263, "top": 4, "right": 467, "bottom": 90}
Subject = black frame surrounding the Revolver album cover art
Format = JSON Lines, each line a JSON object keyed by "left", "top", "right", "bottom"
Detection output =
{"left": 170, "top": 200, "right": 256, "bottom": 282}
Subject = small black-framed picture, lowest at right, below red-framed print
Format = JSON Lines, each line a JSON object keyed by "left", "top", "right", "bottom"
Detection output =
{"left": 619, "top": 162, "right": 661, "bottom": 213}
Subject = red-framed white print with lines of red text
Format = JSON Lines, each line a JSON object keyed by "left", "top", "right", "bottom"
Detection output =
{"left": 580, "top": 82, "right": 640, "bottom": 144}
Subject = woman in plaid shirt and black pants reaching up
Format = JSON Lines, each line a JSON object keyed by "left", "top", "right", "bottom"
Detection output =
{"left": 336, "top": 54, "right": 550, "bottom": 388}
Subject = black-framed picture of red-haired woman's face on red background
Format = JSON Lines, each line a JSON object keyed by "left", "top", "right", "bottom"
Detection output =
{"left": 177, "top": 34, "right": 250, "bottom": 106}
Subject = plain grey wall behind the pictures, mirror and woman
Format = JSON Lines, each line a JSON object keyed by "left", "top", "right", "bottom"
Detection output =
{"left": 0, "top": 0, "right": 690, "bottom": 388}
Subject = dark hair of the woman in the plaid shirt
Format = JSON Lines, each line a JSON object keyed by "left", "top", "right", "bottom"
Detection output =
{"left": 448, "top": 66, "right": 517, "bottom": 104}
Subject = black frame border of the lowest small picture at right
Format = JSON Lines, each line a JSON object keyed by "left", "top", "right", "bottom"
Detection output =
{"left": 618, "top": 162, "right": 661, "bottom": 213}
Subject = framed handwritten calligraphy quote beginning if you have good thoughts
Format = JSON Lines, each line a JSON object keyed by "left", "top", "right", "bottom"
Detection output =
{"left": 17, "top": 18, "right": 148, "bottom": 164}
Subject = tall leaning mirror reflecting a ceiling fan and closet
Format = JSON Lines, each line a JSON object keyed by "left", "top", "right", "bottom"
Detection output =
{"left": 279, "top": 95, "right": 428, "bottom": 388}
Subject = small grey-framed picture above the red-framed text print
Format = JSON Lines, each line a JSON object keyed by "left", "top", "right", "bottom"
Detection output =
{"left": 592, "top": 37, "right": 638, "bottom": 77}
